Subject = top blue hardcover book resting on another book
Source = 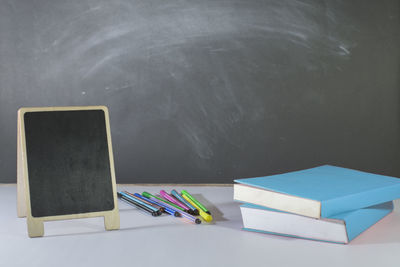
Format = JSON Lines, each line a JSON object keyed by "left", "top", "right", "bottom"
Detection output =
{"left": 234, "top": 165, "right": 400, "bottom": 218}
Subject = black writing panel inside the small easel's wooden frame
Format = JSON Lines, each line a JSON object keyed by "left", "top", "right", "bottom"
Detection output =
{"left": 24, "top": 110, "right": 114, "bottom": 217}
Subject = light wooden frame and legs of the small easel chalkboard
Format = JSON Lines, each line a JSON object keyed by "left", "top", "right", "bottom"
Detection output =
{"left": 17, "top": 106, "right": 120, "bottom": 237}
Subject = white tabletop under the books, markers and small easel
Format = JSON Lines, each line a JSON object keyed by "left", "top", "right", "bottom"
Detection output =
{"left": 0, "top": 185, "right": 400, "bottom": 267}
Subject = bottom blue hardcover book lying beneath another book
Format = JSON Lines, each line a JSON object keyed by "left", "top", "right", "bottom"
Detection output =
{"left": 240, "top": 201, "right": 393, "bottom": 244}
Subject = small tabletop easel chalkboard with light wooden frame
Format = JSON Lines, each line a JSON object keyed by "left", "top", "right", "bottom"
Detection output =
{"left": 17, "top": 106, "right": 119, "bottom": 237}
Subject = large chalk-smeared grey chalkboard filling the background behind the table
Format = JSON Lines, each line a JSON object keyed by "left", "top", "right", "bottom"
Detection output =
{"left": 0, "top": 0, "right": 400, "bottom": 183}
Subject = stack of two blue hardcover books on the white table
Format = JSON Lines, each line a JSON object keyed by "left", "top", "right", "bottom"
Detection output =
{"left": 234, "top": 165, "right": 400, "bottom": 244}
